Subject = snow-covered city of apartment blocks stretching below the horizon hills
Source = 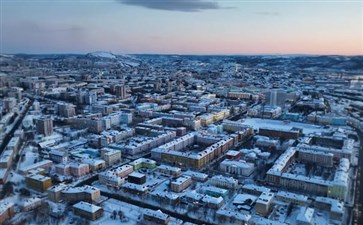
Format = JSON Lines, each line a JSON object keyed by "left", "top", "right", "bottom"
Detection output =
{"left": 0, "top": 52, "right": 363, "bottom": 224}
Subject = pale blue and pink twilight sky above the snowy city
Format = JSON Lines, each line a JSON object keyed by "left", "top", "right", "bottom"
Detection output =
{"left": 0, "top": 0, "right": 363, "bottom": 55}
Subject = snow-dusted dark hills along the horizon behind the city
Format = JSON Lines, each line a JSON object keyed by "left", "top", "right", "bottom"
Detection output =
{"left": 0, "top": 51, "right": 363, "bottom": 74}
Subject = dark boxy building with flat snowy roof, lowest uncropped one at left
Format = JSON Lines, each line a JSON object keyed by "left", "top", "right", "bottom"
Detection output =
{"left": 72, "top": 202, "right": 103, "bottom": 220}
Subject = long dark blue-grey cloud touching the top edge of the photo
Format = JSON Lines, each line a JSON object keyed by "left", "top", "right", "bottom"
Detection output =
{"left": 117, "top": 0, "right": 223, "bottom": 12}
